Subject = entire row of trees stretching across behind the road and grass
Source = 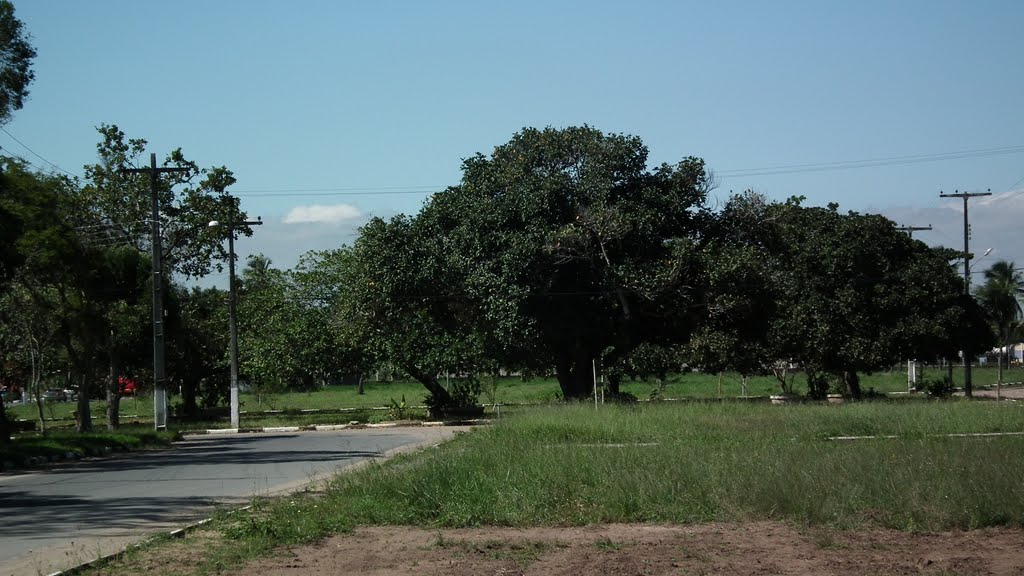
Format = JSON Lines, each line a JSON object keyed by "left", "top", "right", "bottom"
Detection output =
{"left": 0, "top": 125, "right": 1020, "bottom": 429}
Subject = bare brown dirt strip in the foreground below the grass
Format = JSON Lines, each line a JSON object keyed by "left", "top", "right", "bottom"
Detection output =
{"left": 237, "top": 522, "right": 1024, "bottom": 576}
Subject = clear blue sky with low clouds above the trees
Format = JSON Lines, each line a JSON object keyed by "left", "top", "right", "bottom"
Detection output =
{"left": 8, "top": 0, "right": 1024, "bottom": 278}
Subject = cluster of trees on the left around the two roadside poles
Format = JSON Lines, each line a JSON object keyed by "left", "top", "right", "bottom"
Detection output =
{"left": 0, "top": 125, "right": 251, "bottom": 430}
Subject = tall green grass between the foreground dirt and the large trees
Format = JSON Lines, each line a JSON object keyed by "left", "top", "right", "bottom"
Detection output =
{"left": 207, "top": 401, "right": 1024, "bottom": 547}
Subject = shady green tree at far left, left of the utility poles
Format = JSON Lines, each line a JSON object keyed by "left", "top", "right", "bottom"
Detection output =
{"left": 0, "top": 162, "right": 146, "bottom": 429}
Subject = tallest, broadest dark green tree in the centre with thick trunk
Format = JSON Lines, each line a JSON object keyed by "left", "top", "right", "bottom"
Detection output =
{"left": 344, "top": 126, "right": 712, "bottom": 398}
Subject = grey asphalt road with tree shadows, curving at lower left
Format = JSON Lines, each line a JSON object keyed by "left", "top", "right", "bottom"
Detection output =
{"left": 0, "top": 427, "right": 457, "bottom": 576}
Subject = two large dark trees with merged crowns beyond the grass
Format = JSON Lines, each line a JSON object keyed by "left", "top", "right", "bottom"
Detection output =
{"left": 339, "top": 126, "right": 988, "bottom": 399}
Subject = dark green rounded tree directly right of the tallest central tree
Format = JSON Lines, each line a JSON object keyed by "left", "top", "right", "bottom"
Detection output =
{"left": 708, "top": 195, "right": 991, "bottom": 397}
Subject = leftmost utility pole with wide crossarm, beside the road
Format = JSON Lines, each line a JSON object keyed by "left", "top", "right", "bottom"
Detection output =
{"left": 121, "top": 154, "right": 188, "bottom": 430}
